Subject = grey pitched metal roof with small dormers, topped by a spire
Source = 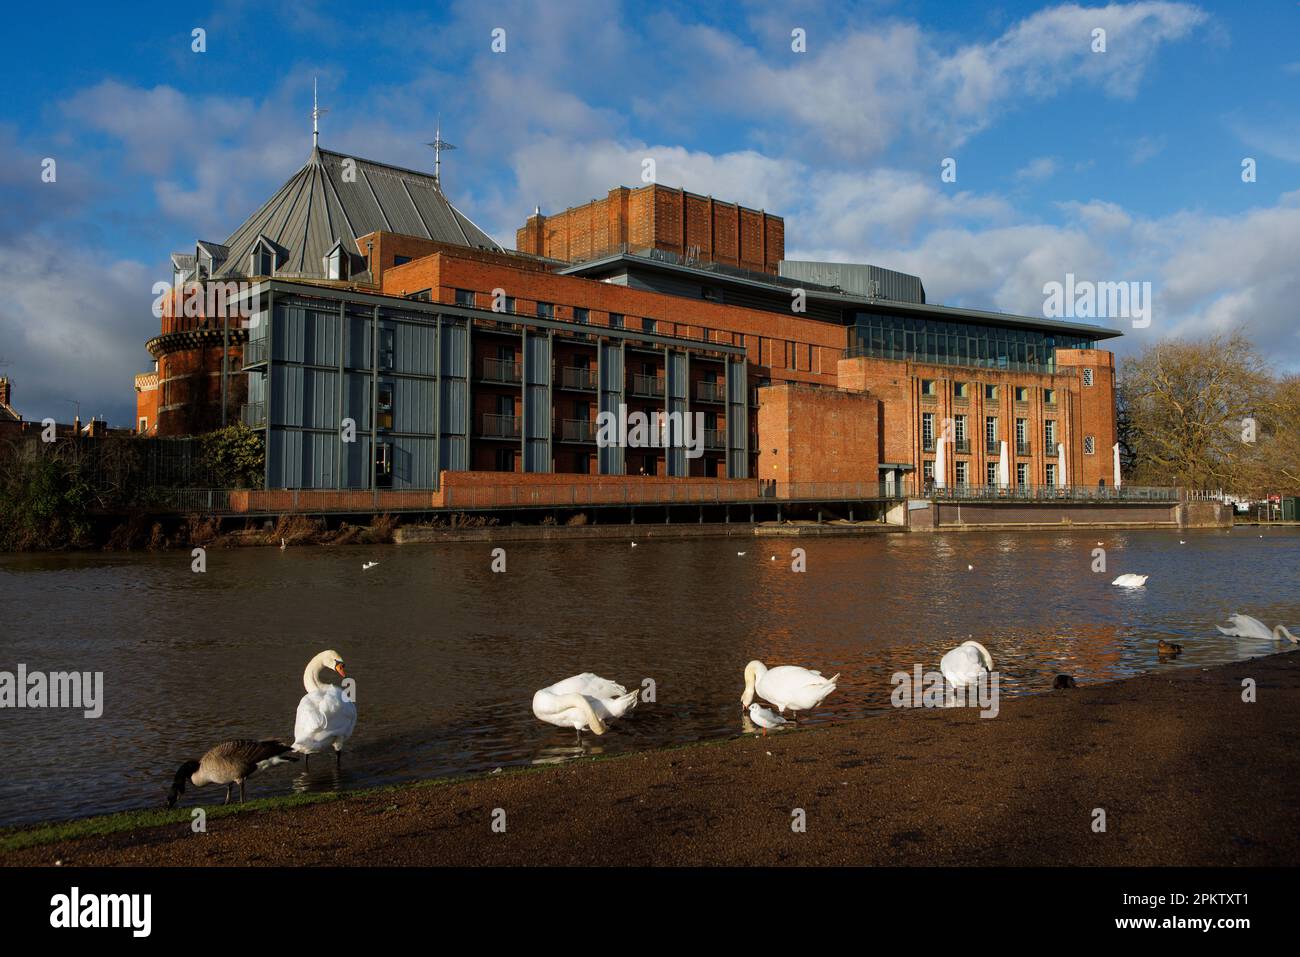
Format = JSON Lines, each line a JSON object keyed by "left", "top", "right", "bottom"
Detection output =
{"left": 215, "top": 148, "right": 501, "bottom": 278}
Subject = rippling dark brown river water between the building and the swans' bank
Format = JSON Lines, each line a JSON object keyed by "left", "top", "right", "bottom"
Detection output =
{"left": 0, "top": 527, "right": 1300, "bottom": 824}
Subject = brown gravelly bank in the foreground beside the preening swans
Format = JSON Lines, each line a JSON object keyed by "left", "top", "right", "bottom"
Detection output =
{"left": 0, "top": 653, "right": 1300, "bottom": 866}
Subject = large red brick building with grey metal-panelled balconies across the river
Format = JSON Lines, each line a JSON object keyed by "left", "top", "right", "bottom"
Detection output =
{"left": 137, "top": 143, "right": 1118, "bottom": 494}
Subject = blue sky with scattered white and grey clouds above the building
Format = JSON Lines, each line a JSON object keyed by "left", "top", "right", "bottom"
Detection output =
{"left": 0, "top": 0, "right": 1300, "bottom": 424}
